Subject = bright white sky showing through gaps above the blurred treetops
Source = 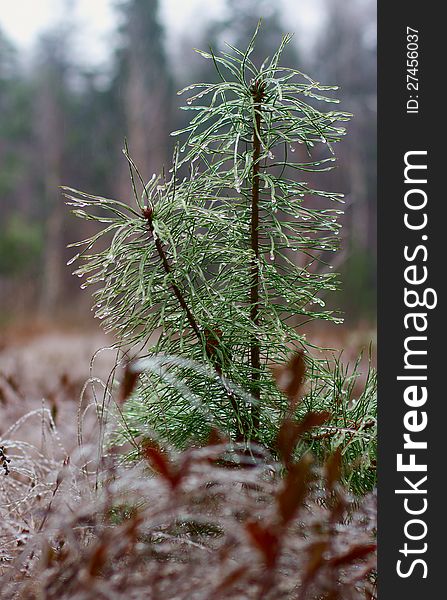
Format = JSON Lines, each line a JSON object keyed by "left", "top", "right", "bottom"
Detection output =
{"left": 0, "top": 0, "right": 324, "bottom": 65}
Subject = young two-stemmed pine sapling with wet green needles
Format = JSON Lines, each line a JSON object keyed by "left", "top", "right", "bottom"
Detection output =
{"left": 65, "top": 29, "right": 372, "bottom": 492}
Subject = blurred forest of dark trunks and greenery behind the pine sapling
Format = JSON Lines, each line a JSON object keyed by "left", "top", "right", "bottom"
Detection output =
{"left": 0, "top": 0, "right": 377, "bottom": 327}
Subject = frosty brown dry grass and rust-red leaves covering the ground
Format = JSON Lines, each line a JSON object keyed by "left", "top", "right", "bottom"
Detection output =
{"left": 0, "top": 331, "right": 376, "bottom": 600}
